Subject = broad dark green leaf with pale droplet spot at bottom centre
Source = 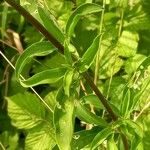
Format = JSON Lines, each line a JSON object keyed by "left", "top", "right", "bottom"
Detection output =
{"left": 71, "top": 127, "right": 100, "bottom": 150}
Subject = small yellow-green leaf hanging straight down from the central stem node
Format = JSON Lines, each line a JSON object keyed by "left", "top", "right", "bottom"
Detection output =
{"left": 63, "top": 70, "right": 74, "bottom": 97}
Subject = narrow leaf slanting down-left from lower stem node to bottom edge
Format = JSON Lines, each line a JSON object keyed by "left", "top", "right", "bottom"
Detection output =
{"left": 91, "top": 127, "right": 113, "bottom": 150}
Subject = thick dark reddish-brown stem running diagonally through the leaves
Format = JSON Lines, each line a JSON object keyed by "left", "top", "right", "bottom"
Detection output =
{"left": 5, "top": 0, "right": 117, "bottom": 121}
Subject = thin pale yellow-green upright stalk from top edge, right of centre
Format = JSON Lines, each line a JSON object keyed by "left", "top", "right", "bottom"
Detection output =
{"left": 94, "top": 0, "right": 106, "bottom": 85}
